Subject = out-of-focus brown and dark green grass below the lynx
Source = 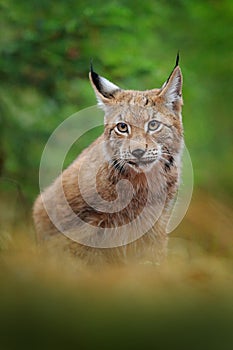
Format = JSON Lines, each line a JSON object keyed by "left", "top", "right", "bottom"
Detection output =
{"left": 0, "top": 194, "right": 233, "bottom": 350}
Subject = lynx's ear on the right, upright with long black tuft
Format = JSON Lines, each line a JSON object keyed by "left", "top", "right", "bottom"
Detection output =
{"left": 159, "top": 54, "right": 183, "bottom": 113}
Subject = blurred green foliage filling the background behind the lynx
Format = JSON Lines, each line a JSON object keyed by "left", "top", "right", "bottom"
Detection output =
{"left": 0, "top": 0, "right": 233, "bottom": 200}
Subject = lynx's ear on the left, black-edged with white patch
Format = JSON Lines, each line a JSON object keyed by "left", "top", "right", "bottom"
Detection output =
{"left": 89, "top": 65, "right": 120, "bottom": 108}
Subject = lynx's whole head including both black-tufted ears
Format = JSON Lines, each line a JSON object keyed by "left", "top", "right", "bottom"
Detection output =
{"left": 90, "top": 55, "right": 183, "bottom": 172}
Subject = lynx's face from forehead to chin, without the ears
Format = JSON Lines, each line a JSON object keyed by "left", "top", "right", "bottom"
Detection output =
{"left": 105, "top": 102, "right": 182, "bottom": 171}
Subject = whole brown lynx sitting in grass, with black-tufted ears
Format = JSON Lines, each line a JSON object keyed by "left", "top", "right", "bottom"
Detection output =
{"left": 33, "top": 55, "right": 183, "bottom": 264}
